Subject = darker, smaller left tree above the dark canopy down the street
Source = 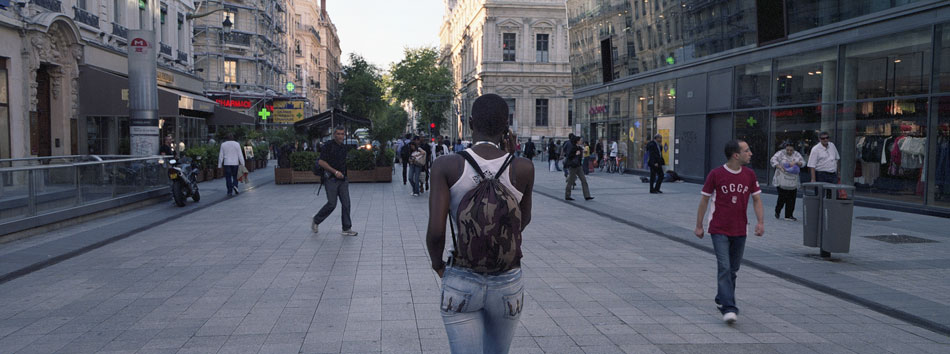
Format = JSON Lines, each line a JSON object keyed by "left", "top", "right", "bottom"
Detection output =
{"left": 340, "top": 53, "right": 386, "bottom": 119}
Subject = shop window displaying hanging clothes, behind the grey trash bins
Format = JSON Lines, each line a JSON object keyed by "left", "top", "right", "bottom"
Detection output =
{"left": 832, "top": 98, "right": 928, "bottom": 203}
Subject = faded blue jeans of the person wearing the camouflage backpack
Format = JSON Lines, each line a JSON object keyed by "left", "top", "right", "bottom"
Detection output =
{"left": 440, "top": 267, "right": 524, "bottom": 354}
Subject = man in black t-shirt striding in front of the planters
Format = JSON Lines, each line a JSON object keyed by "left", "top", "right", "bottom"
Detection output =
{"left": 310, "top": 127, "right": 357, "bottom": 236}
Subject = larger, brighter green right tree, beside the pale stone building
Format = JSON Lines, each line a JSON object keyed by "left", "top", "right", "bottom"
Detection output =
{"left": 391, "top": 47, "right": 454, "bottom": 134}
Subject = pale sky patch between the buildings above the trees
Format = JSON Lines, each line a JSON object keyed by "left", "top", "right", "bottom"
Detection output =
{"left": 327, "top": 0, "right": 445, "bottom": 70}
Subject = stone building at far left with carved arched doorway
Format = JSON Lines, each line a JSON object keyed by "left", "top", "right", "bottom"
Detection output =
{"left": 0, "top": 0, "right": 206, "bottom": 158}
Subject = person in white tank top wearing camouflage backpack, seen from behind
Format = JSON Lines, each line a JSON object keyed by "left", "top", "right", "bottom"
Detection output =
{"left": 426, "top": 94, "right": 534, "bottom": 354}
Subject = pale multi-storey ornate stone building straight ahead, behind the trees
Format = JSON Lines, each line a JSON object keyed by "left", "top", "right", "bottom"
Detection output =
{"left": 439, "top": 0, "right": 574, "bottom": 141}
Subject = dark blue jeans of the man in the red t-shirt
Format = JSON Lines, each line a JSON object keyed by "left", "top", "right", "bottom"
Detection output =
{"left": 711, "top": 234, "right": 746, "bottom": 314}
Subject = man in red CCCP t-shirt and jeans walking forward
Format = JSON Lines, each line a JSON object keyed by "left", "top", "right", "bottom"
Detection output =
{"left": 695, "top": 140, "right": 765, "bottom": 324}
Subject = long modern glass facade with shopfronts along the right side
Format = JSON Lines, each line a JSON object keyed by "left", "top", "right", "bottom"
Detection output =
{"left": 568, "top": 6, "right": 950, "bottom": 208}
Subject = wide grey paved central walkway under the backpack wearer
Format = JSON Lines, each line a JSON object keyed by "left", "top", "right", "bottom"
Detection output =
{"left": 0, "top": 165, "right": 950, "bottom": 353}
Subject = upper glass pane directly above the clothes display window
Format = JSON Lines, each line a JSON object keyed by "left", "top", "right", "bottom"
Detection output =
{"left": 840, "top": 27, "right": 932, "bottom": 100}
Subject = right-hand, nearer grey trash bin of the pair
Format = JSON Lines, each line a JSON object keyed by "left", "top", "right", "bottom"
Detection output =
{"left": 820, "top": 184, "right": 854, "bottom": 253}
